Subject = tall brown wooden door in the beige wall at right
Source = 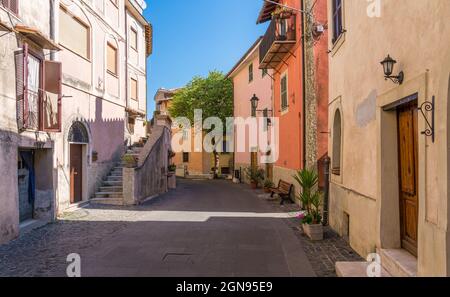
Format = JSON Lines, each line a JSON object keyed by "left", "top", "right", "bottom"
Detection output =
{"left": 398, "top": 104, "right": 419, "bottom": 256}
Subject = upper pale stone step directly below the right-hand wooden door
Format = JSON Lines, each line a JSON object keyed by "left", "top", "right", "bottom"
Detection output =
{"left": 378, "top": 249, "right": 417, "bottom": 277}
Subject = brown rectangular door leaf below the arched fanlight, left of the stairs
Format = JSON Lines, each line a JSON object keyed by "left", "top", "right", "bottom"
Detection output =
{"left": 70, "top": 144, "right": 83, "bottom": 203}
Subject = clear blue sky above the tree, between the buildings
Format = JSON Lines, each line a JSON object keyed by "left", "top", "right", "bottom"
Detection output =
{"left": 145, "top": 0, "right": 266, "bottom": 117}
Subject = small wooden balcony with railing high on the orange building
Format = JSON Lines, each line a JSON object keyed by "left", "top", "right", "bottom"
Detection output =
{"left": 259, "top": 15, "right": 297, "bottom": 69}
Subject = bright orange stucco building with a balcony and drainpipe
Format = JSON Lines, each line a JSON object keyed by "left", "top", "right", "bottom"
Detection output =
{"left": 257, "top": 0, "right": 328, "bottom": 193}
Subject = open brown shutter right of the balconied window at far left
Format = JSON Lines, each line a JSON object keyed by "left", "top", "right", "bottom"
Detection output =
{"left": 41, "top": 61, "right": 62, "bottom": 132}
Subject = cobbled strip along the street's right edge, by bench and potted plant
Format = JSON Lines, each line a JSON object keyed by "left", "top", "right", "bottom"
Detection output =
{"left": 251, "top": 186, "right": 364, "bottom": 277}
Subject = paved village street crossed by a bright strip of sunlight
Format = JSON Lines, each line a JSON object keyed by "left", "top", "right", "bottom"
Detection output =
{"left": 0, "top": 180, "right": 328, "bottom": 277}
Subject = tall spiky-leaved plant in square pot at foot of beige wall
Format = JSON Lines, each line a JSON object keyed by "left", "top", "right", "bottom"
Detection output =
{"left": 294, "top": 169, "right": 323, "bottom": 241}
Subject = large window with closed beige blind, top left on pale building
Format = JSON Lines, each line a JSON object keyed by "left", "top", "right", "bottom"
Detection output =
{"left": 59, "top": 7, "right": 90, "bottom": 59}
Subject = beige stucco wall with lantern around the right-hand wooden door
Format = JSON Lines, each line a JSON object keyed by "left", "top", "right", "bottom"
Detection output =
{"left": 329, "top": 0, "right": 450, "bottom": 275}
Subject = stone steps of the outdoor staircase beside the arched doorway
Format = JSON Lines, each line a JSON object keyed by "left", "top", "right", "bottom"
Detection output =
{"left": 90, "top": 138, "right": 148, "bottom": 206}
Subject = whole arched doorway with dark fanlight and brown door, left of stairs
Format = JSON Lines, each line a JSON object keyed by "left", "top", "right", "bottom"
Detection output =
{"left": 68, "top": 122, "right": 89, "bottom": 204}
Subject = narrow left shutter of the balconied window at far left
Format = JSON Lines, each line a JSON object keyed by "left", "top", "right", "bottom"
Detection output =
{"left": 15, "top": 43, "right": 29, "bottom": 130}
